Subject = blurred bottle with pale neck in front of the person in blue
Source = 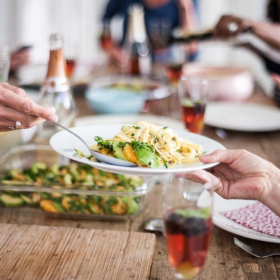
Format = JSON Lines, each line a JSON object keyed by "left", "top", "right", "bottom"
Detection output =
{"left": 124, "top": 4, "right": 151, "bottom": 75}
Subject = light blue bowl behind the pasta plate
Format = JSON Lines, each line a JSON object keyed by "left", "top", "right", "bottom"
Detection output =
{"left": 86, "top": 87, "right": 146, "bottom": 115}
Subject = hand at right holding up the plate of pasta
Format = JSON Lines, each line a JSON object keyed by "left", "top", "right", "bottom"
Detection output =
{"left": 177, "top": 150, "right": 280, "bottom": 216}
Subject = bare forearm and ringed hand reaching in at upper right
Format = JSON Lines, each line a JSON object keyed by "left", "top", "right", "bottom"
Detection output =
{"left": 214, "top": 15, "right": 280, "bottom": 49}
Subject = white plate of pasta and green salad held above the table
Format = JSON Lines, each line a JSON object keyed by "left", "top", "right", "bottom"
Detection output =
{"left": 50, "top": 121, "right": 225, "bottom": 176}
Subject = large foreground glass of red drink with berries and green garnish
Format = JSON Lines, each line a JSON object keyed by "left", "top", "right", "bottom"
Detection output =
{"left": 162, "top": 175, "right": 214, "bottom": 280}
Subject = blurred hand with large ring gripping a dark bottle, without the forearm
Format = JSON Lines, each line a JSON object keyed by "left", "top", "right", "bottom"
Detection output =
{"left": 214, "top": 15, "right": 254, "bottom": 39}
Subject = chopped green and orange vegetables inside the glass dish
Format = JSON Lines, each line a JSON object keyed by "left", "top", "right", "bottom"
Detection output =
{"left": 0, "top": 162, "right": 143, "bottom": 215}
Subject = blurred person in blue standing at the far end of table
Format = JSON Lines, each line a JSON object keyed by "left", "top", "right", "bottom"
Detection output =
{"left": 100, "top": 0, "right": 197, "bottom": 61}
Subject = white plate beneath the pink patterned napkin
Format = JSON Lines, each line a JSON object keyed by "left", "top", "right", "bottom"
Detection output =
{"left": 213, "top": 193, "right": 280, "bottom": 243}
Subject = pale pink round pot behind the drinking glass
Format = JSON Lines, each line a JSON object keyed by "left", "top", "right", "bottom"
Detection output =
{"left": 184, "top": 64, "right": 254, "bottom": 101}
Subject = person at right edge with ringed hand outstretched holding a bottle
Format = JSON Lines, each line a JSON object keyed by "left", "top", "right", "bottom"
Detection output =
{"left": 214, "top": 0, "right": 280, "bottom": 107}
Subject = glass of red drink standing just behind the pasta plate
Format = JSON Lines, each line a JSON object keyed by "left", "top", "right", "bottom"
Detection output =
{"left": 178, "top": 76, "right": 208, "bottom": 133}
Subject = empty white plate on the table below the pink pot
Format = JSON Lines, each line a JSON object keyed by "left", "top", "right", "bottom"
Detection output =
{"left": 205, "top": 102, "right": 280, "bottom": 132}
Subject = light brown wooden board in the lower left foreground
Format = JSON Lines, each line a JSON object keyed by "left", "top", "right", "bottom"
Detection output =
{"left": 0, "top": 224, "right": 155, "bottom": 280}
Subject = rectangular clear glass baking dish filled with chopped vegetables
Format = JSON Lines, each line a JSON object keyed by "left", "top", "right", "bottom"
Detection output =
{"left": 0, "top": 143, "right": 153, "bottom": 220}
